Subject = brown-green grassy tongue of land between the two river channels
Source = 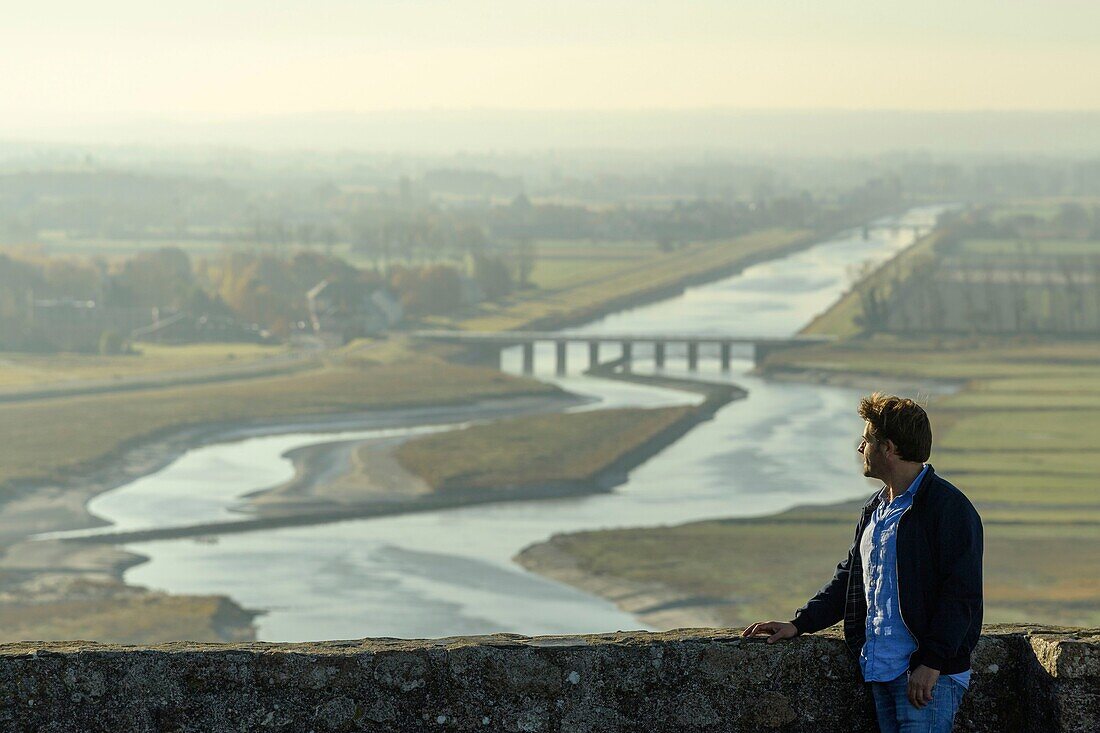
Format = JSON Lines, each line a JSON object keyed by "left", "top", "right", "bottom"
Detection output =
{"left": 60, "top": 365, "right": 747, "bottom": 544}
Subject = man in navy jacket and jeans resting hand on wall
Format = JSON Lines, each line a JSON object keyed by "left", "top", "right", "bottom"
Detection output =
{"left": 741, "top": 393, "right": 982, "bottom": 733}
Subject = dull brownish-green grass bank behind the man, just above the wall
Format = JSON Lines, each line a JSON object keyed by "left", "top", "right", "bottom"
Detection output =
{"left": 551, "top": 504, "right": 1100, "bottom": 626}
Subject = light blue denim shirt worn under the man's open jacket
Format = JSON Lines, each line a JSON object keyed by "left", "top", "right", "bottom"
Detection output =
{"left": 859, "top": 466, "right": 970, "bottom": 687}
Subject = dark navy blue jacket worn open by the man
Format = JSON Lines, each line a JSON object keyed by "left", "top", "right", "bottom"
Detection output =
{"left": 792, "top": 466, "right": 982, "bottom": 675}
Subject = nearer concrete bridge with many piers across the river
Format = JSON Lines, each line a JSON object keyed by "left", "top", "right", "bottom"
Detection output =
{"left": 410, "top": 330, "right": 832, "bottom": 374}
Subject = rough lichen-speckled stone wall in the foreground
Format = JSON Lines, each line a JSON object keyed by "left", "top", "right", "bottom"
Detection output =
{"left": 0, "top": 626, "right": 1100, "bottom": 733}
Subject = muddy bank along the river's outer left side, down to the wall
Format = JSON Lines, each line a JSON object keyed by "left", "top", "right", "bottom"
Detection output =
{"left": 0, "top": 391, "right": 583, "bottom": 642}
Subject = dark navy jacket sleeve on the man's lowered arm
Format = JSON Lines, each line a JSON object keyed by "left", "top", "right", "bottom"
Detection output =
{"left": 913, "top": 500, "right": 985, "bottom": 670}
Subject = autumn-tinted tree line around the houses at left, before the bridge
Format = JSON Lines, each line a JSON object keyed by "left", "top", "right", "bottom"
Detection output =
{"left": 0, "top": 248, "right": 526, "bottom": 351}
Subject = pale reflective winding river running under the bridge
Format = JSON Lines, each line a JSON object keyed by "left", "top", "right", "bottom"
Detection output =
{"left": 62, "top": 203, "right": 941, "bottom": 641}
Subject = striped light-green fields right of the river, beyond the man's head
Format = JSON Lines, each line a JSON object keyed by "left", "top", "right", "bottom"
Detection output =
{"left": 769, "top": 339, "right": 1100, "bottom": 530}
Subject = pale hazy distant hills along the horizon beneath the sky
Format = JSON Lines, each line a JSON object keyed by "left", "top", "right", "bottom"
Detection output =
{"left": 0, "top": 109, "right": 1100, "bottom": 156}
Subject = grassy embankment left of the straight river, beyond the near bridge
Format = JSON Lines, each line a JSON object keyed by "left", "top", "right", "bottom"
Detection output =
{"left": 458, "top": 229, "right": 810, "bottom": 330}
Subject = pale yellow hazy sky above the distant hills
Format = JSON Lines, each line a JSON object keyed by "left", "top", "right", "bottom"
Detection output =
{"left": 0, "top": 0, "right": 1100, "bottom": 132}
